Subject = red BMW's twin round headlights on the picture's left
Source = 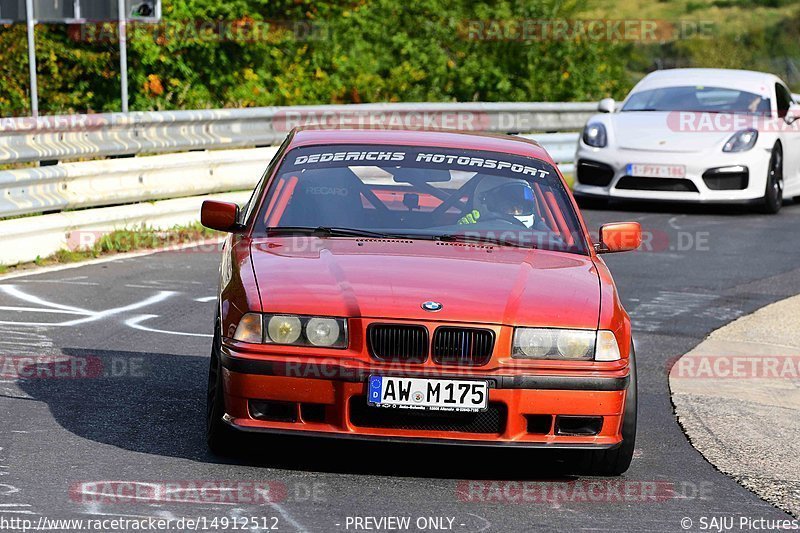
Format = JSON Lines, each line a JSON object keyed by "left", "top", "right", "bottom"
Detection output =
{"left": 264, "top": 315, "right": 347, "bottom": 348}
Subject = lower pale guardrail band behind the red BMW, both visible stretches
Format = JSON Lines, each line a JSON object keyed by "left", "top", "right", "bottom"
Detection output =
{"left": 0, "top": 133, "right": 578, "bottom": 217}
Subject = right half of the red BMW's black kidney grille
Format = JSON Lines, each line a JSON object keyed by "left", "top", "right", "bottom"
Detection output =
{"left": 433, "top": 327, "right": 494, "bottom": 366}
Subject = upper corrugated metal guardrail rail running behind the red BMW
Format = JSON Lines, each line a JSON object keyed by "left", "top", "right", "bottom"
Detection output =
{"left": 0, "top": 102, "right": 596, "bottom": 164}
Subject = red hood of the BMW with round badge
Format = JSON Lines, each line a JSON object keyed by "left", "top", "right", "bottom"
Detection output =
{"left": 251, "top": 237, "right": 600, "bottom": 328}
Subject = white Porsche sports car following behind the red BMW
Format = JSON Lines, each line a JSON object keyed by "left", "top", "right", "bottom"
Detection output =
{"left": 574, "top": 69, "right": 800, "bottom": 213}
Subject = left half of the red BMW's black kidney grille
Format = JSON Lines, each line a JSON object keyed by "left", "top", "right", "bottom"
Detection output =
{"left": 367, "top": 324, "right": 428, "bottom": 363}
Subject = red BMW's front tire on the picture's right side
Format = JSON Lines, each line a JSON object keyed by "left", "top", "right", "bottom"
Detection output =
{"left": 581, "top": 346, "right": 638, "bottom": 476}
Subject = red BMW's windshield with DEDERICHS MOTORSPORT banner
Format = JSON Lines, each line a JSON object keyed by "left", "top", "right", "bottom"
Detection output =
{"left": 254, "top": 145, "right": 587, "bottom": 254}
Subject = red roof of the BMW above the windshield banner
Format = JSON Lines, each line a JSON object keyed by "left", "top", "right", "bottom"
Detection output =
{"left": 289, "top": 126, "right": 555, "bottom": 166}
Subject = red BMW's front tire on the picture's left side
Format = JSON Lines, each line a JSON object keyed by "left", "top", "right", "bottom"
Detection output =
{"left": 206, "top": 321, "right": 239, "bottom": 456}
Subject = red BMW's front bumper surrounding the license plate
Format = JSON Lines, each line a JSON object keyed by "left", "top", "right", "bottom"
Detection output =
{"left": 220, "top": 347, "right": 629, "bottom": 449}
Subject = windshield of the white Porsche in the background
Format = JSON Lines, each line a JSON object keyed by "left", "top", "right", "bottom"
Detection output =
{"left": 622, "top": 86, "right": 770, "bottom": 114}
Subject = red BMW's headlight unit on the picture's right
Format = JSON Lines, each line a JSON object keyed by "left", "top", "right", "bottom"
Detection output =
{"left": 511, "top": 328, "right": 620, "bottom": 361}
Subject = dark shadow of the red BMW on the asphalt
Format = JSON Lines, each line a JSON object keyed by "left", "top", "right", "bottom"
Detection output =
{"left": 19, "top": 348, "right": 572, "bottom": 480}
